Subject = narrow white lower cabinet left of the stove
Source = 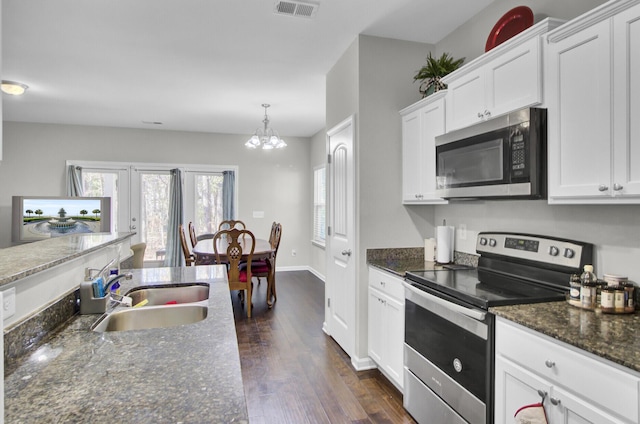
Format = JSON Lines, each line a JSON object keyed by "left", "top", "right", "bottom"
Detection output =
{"left": 368, "top": 267, "right": 404, "bottom": 391}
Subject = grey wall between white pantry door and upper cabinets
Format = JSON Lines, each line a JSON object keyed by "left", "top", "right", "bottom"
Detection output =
{"left": 327, "top": 35, "right": 433, "bottom": 364}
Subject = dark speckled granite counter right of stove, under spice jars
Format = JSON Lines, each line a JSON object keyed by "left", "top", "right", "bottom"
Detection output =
{"left": 489, "top": 302, "right": 640, "bottom": 372}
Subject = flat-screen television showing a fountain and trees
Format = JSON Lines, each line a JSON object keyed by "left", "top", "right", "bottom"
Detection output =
{"left": 11, "top": 196, "right": 111, "bottom": 243}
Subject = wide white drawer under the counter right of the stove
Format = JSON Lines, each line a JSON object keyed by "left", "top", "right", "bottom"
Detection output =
{"left": 496, "top": 318, "right": 640, "bottom": 422}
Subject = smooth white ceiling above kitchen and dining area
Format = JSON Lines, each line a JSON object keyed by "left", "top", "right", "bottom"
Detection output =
{"left": 2, "top": 0, "right": 492, "bottom": 137}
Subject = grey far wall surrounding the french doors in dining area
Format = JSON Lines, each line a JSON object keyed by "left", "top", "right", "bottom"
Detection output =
{"left": 0, "top": 122, "right": 313, "bottom": 268}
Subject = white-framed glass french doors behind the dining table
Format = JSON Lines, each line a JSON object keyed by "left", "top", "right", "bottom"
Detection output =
{"left": 67, "top": 161, "right": 238, "bottom": 261}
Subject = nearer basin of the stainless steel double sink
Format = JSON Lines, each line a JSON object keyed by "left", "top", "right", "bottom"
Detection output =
{"left": 91, "top": 302, "right": 208, "bottom": 332}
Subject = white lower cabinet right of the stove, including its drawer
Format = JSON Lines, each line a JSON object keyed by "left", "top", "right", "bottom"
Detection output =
{"left": 495, "top": 318, "right": 640, "bottom": 424}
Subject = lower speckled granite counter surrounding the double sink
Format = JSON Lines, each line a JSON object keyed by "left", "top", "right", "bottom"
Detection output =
{"left": 5, "top": 266, "right": 248, "bottom": 423}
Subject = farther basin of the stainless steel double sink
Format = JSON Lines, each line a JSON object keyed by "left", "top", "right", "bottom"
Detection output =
{"left": 127, "top": 283, "right": 209, "bottom": 306}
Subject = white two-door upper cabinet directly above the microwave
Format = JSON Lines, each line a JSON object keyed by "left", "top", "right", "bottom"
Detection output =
{"left": 442, "top": 18, "right": 563, "bottom": 131}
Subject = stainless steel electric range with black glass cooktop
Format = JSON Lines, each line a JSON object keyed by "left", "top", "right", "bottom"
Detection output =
{"left": 404, "top": 232, "right": 593, "bottom": 424}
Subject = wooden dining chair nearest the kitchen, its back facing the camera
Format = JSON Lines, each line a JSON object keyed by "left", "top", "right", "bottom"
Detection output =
{"left": 213, "top": 228, "right": 256, "bottom": 318}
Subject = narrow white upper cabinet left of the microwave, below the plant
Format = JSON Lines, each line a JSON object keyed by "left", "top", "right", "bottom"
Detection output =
{"left": 400, "top": 91, "right": 446, "bottom": 204}
